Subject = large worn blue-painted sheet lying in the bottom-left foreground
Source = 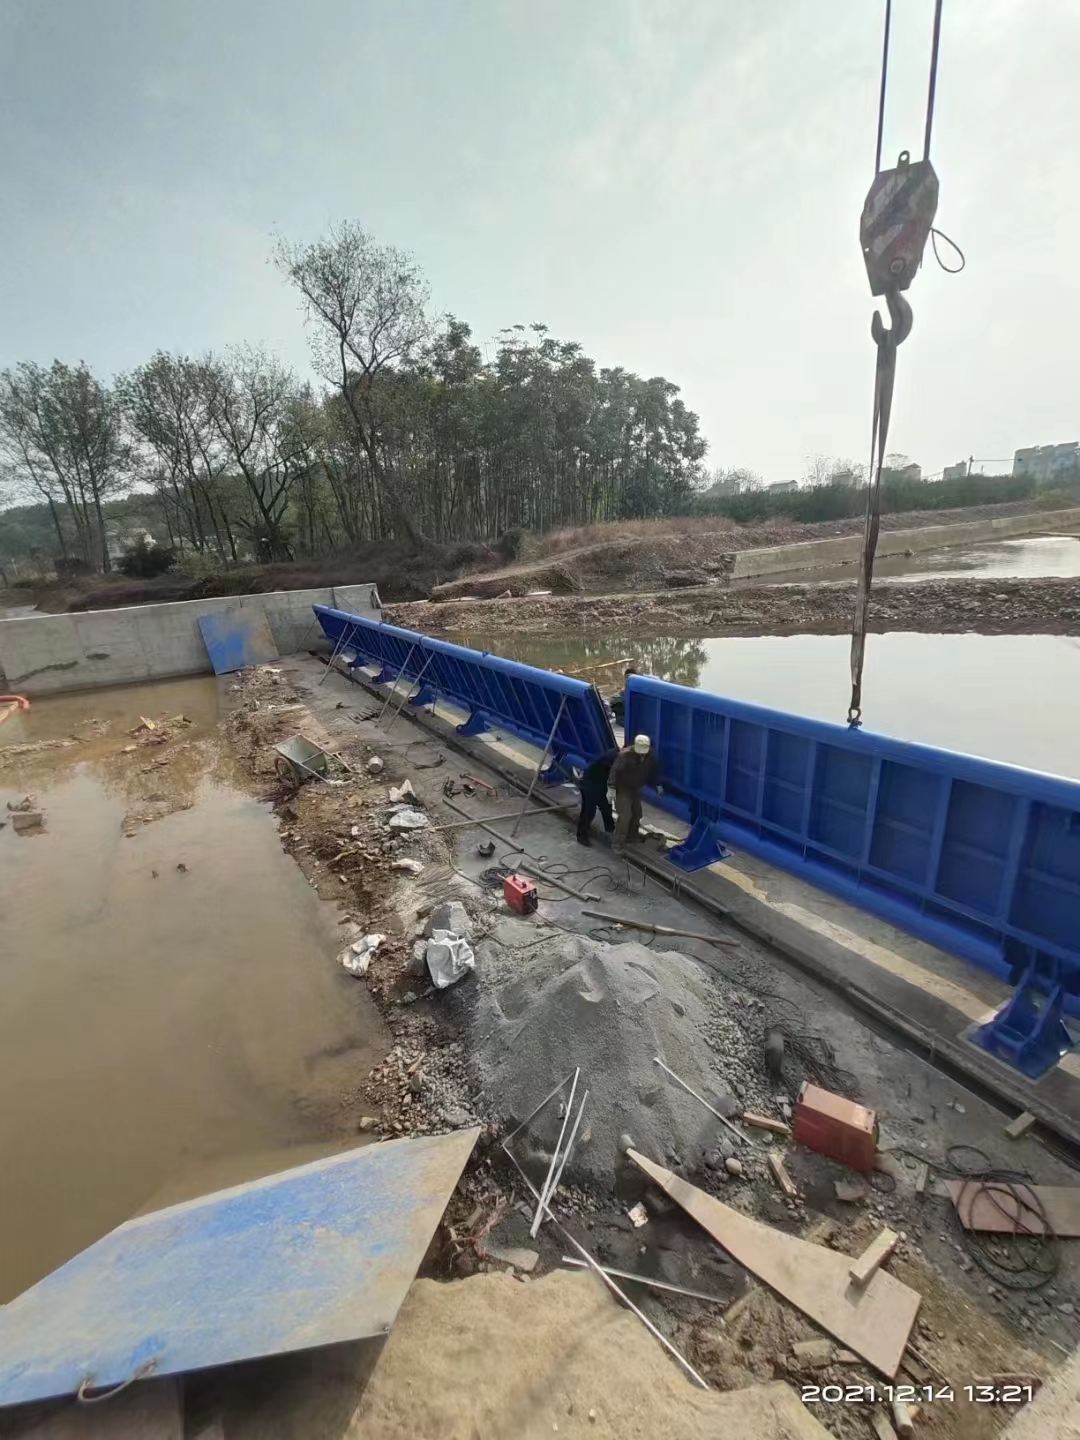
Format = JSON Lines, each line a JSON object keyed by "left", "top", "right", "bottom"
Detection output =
{"left": 0, "top": 1129, "right": 480, "bottom": 1405}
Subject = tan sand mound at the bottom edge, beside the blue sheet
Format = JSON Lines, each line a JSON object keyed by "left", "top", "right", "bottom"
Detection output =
{"left": 347, "top": 1273, "right": 827, "bottom": 1440}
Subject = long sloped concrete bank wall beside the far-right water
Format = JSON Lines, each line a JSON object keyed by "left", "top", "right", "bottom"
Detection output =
{"left": 729, "top": 510, "right": 1080, "bottom": 580}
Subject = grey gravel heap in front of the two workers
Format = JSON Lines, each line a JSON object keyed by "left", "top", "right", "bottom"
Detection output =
{"left": 471, "top": 932, "right": 740, "bottom": 1189}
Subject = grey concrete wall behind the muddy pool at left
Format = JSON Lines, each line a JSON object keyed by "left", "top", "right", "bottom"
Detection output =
{"left": 0, "top": 585, "right": 382, "bottom": 696}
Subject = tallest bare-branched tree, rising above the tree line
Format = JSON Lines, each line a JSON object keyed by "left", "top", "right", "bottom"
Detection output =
{"left": 275, "top": 220, "right": 431, "bottom": 540}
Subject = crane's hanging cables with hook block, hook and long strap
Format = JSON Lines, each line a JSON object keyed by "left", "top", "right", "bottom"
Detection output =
{"left": 848, "top": 0, "right": 963, "bottom": 729}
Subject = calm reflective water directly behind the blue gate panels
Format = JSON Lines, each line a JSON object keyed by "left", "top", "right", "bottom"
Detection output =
{"left": 454, "top": 632, "right": 1080, "bottom": 779}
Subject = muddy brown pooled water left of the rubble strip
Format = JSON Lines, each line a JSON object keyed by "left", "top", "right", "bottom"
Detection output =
{"left": 0, "top": 678, "right": 384, "bottom": 1302}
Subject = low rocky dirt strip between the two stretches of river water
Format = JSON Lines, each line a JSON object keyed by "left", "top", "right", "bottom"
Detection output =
{"left": 386, "top": 579, "right": 1080, "bottom": 635}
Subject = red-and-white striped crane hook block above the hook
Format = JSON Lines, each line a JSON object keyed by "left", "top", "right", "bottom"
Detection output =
{"left": 858, "top": 150, "right": 937, "bottom": 295}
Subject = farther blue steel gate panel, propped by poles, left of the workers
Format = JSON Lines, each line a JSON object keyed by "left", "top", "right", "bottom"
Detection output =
{"left": 312, "top": 605, "right": 615, "bottom": 778}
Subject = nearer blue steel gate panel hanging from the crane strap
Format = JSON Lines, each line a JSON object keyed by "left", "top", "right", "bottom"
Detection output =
{"left": 626, "top": 675, "right": 1080, "bottom": 1074}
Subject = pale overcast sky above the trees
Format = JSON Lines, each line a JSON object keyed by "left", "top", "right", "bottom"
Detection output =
{"left": 0, "top": 0, "right": 1080, "bottom": 481}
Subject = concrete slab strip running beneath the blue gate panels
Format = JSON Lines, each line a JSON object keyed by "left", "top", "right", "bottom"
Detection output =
{"left": 316, "top": 660, "right": 1080, "bottom": 1146}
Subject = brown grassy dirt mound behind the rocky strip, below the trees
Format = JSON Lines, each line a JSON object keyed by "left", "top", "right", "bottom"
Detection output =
{"left": 431, "top": 500, "right": 1071, "bottom": 600}
